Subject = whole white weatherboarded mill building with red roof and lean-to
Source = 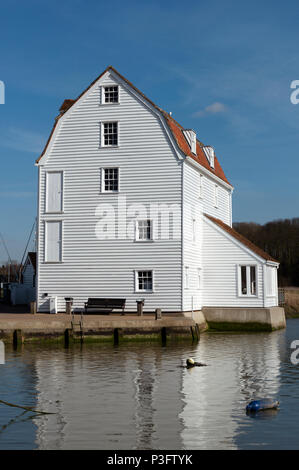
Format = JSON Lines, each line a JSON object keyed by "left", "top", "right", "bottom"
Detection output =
{"left": 37, "top": 66, "right": 284, "bottom": 324}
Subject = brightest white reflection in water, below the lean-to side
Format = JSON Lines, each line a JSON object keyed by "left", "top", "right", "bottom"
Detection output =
{"left": 181, "top": 333, "right": 280, "bottom": 449}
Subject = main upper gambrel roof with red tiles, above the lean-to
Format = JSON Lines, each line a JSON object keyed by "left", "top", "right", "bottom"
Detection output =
{"left": 36, "top": 65, "right": 230, "bottom": 184}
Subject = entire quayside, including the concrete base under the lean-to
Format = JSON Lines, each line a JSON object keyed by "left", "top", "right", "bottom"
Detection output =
{"left": 0, "top": 307, "right": 286, "bottom": 344}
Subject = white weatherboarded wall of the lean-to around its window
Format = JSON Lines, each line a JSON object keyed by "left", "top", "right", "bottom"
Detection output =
{"left": 203, "top": 218, "right": 264, "bottom": 307}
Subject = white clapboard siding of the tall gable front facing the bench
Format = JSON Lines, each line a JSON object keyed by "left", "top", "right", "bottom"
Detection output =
{"left": 38, "top": 73, "right": 182, "bottom": 311}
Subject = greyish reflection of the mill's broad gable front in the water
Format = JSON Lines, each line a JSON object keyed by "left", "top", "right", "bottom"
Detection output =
{"left": 35, "top": 345, "right": 182, "bottom": 449}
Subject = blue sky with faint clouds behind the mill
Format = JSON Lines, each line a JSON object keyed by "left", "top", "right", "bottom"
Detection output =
{"left": 0, "top": 0, "right": 299, "bottom": 261}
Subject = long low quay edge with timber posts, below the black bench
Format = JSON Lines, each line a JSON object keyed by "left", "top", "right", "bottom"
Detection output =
{"left": 0, "top": 314, "right": 206, "bottom": 344}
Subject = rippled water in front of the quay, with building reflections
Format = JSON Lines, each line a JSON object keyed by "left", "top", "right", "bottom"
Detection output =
{"left": 0, "top": 320, "right": 299, "bottom": 449}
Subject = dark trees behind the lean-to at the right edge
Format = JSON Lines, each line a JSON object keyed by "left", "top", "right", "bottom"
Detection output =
{"left": 233, "top": 218, "right": 299, "bottom": 287}
